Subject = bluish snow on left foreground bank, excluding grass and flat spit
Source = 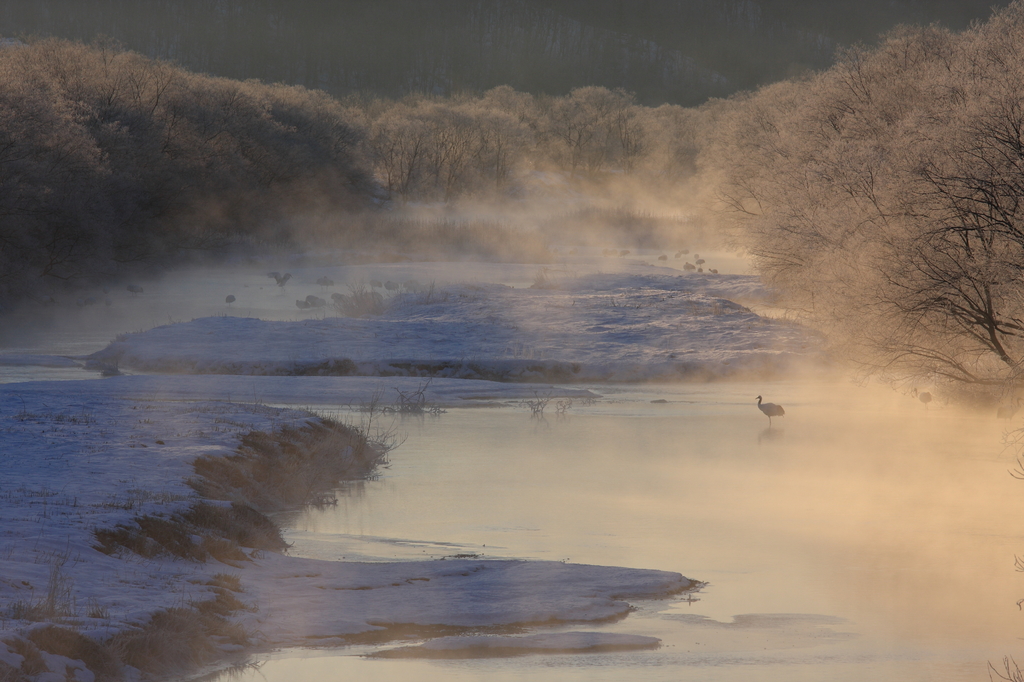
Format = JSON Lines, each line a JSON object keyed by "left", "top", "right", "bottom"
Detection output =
{"left": 0, "top": 381, "right": 309, "bottom": 682}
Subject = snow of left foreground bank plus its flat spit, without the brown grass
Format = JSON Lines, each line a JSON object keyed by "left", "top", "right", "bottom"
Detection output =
{"left": 0, "top": 377, "right": 694, "bottom": 682}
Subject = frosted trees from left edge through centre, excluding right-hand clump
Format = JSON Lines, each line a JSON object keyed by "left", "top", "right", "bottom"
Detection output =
{"left": 0, "top": 38, "right": 702, "bottom": 304}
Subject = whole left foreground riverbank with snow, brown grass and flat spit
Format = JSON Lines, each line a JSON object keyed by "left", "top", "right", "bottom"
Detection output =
{"left": 0, "top": 377, "right": 695, "bottom": 681}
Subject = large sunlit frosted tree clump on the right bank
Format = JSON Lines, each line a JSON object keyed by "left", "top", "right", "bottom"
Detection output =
{"left": 699, "top": 0, "right": 1024, "bottom": 389}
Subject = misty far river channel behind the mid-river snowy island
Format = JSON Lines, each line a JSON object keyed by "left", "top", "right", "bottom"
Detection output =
{"left": 0, "top": 247, "right": 752, "bottom": 376}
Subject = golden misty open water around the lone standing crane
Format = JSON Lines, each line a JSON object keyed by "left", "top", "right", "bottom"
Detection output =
{"left": 224, "top": 384, "right": 1024, "bottom": 682}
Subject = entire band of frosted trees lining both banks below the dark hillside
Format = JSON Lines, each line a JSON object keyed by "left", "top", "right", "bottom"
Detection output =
{"left": 12, "top": 0, "right": 1024, "bottom": 395}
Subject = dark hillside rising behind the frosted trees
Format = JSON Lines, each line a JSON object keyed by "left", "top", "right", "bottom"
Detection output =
{"left": 0, "top": 0, "right": 1006, "bottom": 105}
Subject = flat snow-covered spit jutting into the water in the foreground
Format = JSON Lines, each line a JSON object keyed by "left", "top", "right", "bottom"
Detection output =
{"left": 232, "top": 556, "right": 695, "bottom": 645}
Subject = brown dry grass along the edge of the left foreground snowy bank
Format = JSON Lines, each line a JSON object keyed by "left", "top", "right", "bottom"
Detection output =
{"left": 52, "top": 419, "right": 387, "bottom": 682}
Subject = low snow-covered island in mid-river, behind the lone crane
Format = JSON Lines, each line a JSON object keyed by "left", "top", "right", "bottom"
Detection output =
{"left": 88, "top": 273, "right": 825, "bottom": 383}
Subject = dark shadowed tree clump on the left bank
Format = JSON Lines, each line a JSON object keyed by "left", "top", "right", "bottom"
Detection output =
{"left": 0, "top": 39, "right": 375, "bottom": 303}
